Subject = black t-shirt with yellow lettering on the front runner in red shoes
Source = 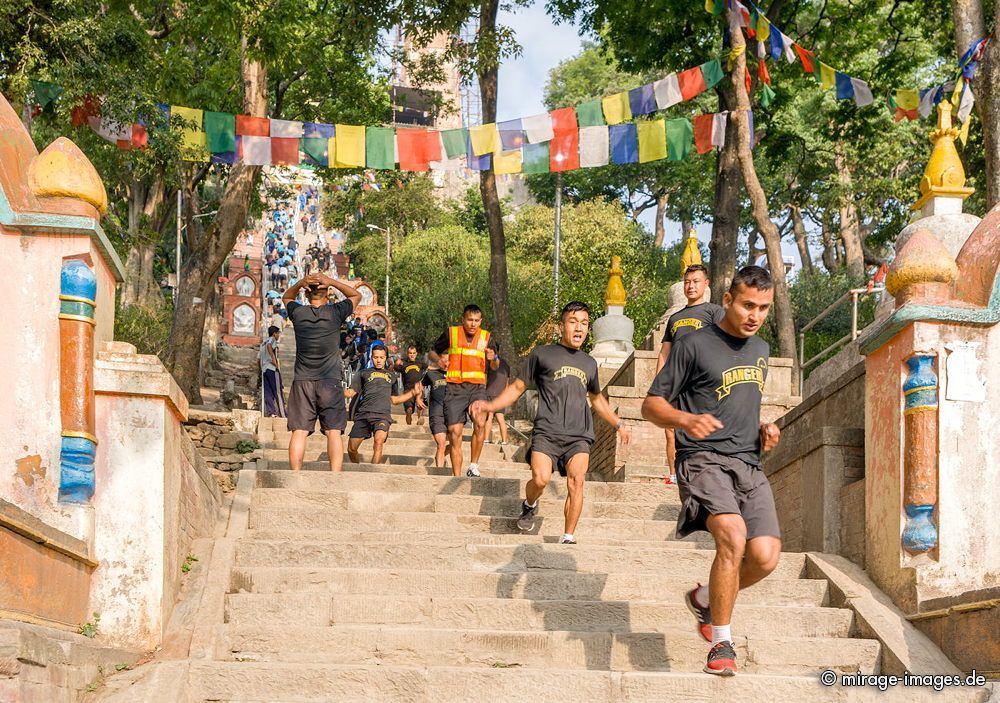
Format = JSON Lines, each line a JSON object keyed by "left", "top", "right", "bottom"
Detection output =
{"left": 649, "top": 325, "right": 770, "bottom": 466}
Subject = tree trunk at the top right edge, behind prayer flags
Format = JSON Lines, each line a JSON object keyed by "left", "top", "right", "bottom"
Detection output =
{"left": 951, "top": 0, "right": 1000, "bottom": 210}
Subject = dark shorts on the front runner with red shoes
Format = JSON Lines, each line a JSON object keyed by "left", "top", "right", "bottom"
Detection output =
{"left": 677, "top": 452, "right": 781, "bottom": 539}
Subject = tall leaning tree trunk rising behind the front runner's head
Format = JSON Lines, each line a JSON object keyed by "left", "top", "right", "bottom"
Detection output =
{"left": 727, "top": 9, "right": 798, "bottom": 364}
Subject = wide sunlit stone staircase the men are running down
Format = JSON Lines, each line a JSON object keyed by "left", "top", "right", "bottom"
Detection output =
{"left": 127, "top": 412, "right": 992, "bottom": 702}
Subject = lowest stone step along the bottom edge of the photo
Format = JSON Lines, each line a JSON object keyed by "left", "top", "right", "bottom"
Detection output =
{"left": 187, "top": 662, "right": 981, "bottom": 703}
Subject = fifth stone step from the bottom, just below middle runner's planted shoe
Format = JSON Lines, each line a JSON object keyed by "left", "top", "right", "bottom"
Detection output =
{"left": 236, "top": 538, "right": 805, "bottom": 583}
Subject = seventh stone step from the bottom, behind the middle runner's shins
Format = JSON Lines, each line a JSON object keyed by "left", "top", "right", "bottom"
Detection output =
{"left": 250, "top": 484, "right": 680, "bottom": 520}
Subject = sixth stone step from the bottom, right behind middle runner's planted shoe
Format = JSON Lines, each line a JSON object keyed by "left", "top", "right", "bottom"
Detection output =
{"left": 249, "top": 508, "right": 677, "bottom": 542}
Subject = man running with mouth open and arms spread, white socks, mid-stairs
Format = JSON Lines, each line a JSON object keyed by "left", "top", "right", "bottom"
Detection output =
{"left": 472, "top": 302, "right": 632, "bottom": 544}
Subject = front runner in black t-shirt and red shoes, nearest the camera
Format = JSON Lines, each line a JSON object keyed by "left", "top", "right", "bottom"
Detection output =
{"left": 642, "top": 266, "right": 781, "bottom": 676}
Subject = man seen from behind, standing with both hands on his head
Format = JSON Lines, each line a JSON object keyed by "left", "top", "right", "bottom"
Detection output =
{"left": 282, "top": 273, "right": 361, "bottom": 471}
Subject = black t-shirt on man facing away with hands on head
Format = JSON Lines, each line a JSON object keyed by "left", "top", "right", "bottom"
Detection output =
{"left": 288, "top": 298, "right": 354, "bottom": 381}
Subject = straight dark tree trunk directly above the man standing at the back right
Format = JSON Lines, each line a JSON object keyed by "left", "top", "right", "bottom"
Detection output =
{"left": 708, "top": 81, "right": 742, "bottom": 303}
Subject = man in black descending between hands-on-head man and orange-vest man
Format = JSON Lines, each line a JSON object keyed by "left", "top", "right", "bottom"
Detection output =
{"left": 344, "top": 347, "right": 424, "bottom": 464}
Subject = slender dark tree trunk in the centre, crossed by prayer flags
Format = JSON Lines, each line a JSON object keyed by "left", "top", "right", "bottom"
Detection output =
{"left": 479, "top": 0, "right": 520, "bottom": 375}
